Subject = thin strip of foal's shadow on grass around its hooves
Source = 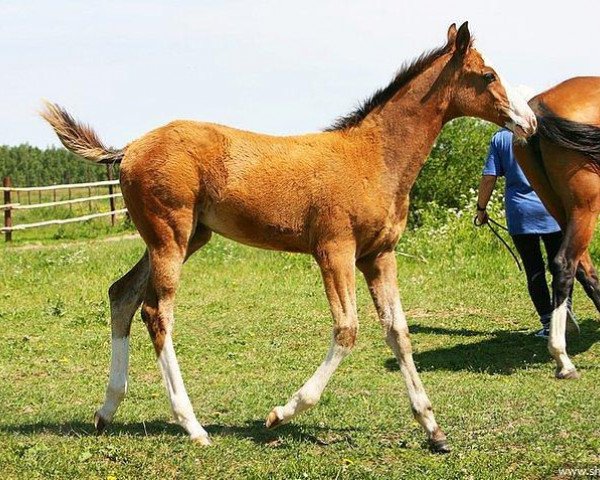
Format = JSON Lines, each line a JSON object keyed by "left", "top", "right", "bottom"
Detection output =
{"left": 0, "top": 420, "right": 358, "bottom": 446}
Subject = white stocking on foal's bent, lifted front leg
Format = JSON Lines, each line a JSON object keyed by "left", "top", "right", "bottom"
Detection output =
{"left": 274, "top": 340, "right": 350, "bottom": 423}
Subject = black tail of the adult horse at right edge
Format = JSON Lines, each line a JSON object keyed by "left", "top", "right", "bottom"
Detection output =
{"left": 537, "top": 102, "right": 600, "bottom": 164}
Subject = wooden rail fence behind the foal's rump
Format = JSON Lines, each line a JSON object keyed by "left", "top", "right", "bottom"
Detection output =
{"left": 0, "top": 173, "right": 127, "bottom": 242}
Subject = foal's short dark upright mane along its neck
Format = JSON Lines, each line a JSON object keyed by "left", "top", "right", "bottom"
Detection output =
{"left": 325, "top": 43, "right": 451, "bottom": 132}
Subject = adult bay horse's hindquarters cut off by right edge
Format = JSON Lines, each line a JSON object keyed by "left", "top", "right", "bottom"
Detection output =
{"left": 513, "top": 77, "right": 600, "bottom": 379}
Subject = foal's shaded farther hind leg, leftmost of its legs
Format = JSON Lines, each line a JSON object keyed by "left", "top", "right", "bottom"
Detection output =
{"left": 94, "top": 252, "right": 149, "bottom": 433}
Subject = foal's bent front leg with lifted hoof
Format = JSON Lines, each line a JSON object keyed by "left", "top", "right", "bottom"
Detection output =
{"left": 265, "top": 245, "right": 358, "bottom": 428}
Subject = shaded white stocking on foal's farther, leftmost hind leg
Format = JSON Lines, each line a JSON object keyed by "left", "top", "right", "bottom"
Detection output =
{"left": 98, "top": 337, "right": 129, "bottom": 422}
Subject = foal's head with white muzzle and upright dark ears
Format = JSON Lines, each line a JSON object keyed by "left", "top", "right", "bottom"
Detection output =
{"left": 448, "top": 22, "right": 537, "bottom": 137}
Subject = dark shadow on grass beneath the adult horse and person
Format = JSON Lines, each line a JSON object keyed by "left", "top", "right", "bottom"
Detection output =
{"left": 385, "top": 319, "right": 600, "bottom": 375}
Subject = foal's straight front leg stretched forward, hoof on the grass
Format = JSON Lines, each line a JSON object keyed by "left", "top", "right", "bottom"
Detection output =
{"left": 357, "top": 251, "right": 450, "bottom": 453}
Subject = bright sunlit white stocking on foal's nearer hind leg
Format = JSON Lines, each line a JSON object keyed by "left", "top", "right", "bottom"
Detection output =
{"left": 157, "top": 333, "right": 209, "bottom": 443}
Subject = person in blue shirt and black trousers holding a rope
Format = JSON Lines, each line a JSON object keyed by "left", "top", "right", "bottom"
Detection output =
{"left": 477, "top": 129, "right": 576, "bottom": 338}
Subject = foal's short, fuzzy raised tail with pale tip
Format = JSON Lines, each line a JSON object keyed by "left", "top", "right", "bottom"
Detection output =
{"left": 40, "top": 102, "right": 125, "bottom": 164}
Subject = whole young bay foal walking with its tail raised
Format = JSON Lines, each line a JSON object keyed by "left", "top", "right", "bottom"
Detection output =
{"left": 42, "top": 22, "right": 536, "bottom": 452}
